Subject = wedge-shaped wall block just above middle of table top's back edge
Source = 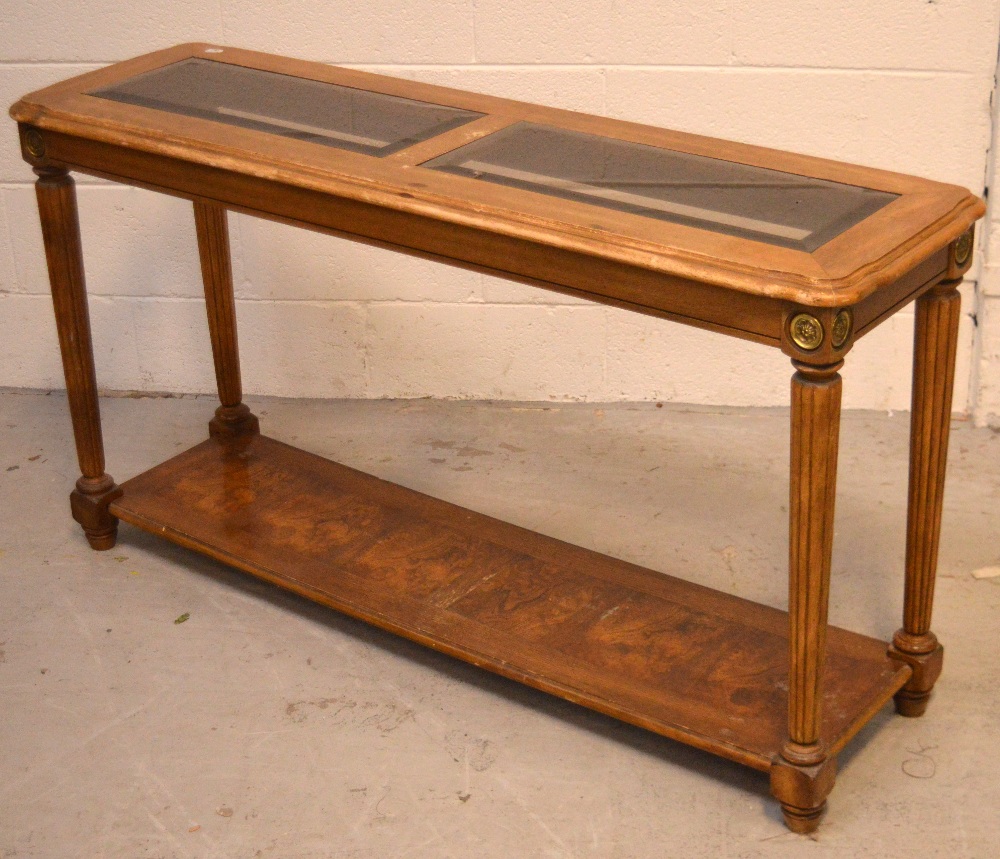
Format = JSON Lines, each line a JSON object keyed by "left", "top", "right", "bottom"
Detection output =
{"left": 365, "top": 66, "right": 604, "bottom": 114}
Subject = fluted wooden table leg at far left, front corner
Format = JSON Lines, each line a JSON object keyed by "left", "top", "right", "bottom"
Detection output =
{"left": 35, "top": 167, "right": 121, "bottom": 549}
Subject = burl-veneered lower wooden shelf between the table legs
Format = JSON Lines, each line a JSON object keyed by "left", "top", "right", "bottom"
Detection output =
{"left": 111, "top": 436, "right": 910, "bottom": 770}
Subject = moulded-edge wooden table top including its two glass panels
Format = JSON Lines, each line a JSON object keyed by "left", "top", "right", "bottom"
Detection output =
{"left": 11, "top": 44, "right": 984, "bottom": 307}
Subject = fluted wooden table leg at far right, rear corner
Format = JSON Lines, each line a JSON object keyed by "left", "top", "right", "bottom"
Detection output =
{"left": 889, "top": 280, "right": 961, "bottom": 716}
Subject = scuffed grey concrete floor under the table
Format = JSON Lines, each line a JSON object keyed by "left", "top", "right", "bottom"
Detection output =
{"left": 0, "top": 393, "right": 1000, "bottom": 859}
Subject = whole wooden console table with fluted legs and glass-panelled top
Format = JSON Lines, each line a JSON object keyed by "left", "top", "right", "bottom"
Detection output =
{"left": 11, "top": 44, "right": 984, "bottom": 832}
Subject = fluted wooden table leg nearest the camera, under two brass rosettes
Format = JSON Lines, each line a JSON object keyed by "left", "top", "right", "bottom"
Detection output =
{"left": 771, "top": 362, "right": 843, "bottom": 833}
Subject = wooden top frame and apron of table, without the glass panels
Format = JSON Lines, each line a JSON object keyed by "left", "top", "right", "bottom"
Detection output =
{"left": 11, "top": 44, "right": 985, "bottom": 352}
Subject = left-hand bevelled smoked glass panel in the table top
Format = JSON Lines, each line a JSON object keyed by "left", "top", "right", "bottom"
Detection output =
{"left": 88, "top": 57, "right": 482, "bottom": 156}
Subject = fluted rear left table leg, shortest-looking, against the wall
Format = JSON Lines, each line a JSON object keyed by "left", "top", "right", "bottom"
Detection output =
{"left": 194, "top": 200, "right": 260, "bottom": 437}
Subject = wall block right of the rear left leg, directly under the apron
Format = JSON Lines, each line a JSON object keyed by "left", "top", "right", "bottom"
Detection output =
{"left": 230, "top": 215, "right": 481, "bottom": 302}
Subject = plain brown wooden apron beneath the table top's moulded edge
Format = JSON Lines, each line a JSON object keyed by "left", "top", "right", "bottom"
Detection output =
{"left": 37, "top": 128, "right": 947, "bottom": 356}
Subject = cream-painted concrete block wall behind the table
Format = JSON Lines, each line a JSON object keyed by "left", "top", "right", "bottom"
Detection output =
{"left": 0, "top": 0, "right": 1000, "bottom": 412}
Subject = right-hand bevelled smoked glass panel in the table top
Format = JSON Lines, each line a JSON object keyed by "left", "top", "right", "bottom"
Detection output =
{"left": 422, "top": 122, "right": 897, "bottom": 251}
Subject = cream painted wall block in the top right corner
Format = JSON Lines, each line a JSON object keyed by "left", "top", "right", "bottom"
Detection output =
{"left": 727, "top": 0, "right": 997, "bottom": 75}
